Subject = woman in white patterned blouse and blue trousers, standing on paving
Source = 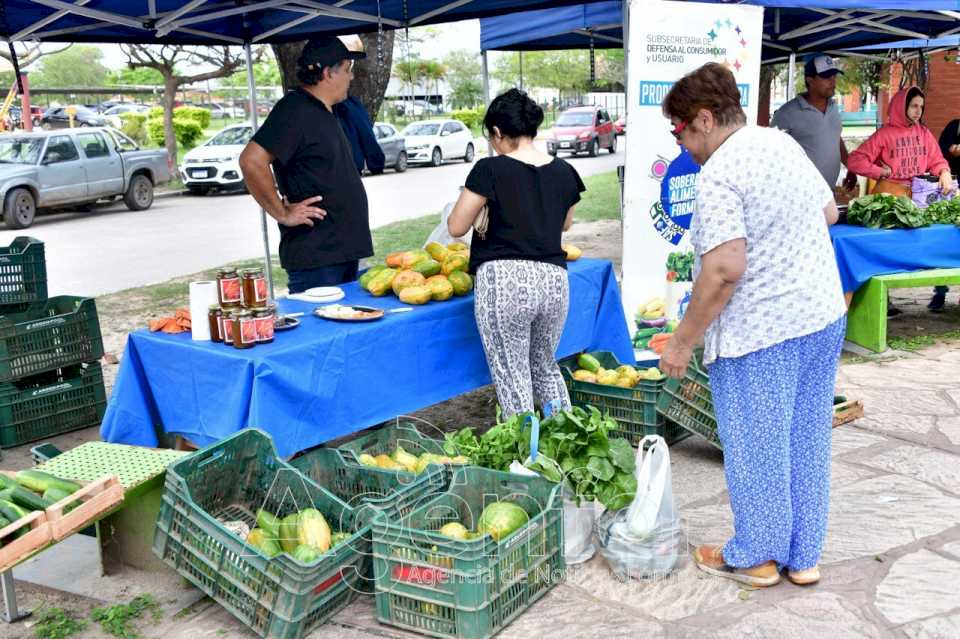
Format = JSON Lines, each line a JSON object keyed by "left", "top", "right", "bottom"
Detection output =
{"left": 660, "top": 62, "right": 846, "bottom": 587}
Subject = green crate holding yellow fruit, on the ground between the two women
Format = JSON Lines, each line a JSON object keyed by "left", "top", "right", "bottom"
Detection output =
{"left": 560, "top": 351, "right": 690, "bottom": 447}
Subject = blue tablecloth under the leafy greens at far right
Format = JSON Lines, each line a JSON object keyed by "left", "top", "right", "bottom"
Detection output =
{"left": 830, "top": 224, "right": 960, "bottom": 293}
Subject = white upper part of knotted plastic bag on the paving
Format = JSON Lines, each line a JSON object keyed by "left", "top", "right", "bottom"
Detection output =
{"left": 627, "top": 435, "right": 677, "bottom": 537}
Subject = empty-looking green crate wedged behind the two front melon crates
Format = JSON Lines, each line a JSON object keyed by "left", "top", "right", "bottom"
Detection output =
{"left": 290, "top": 448, "right": 445, "bottom": 523}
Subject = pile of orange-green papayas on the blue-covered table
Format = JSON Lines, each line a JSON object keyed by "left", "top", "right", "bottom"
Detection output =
{"left": 360, "top": 242, "right": 473, "bottom": 304}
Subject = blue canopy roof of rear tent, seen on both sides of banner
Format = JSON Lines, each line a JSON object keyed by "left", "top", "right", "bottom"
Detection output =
{"left": 480, "top": 0, "right": 960, "bottom": 62}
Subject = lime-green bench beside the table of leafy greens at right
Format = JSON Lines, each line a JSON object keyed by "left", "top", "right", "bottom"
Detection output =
{"left": 847, "top": 268, "right": 960, "bottom": 353}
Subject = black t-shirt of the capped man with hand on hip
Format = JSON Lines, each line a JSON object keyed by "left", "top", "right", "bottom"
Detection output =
{"left": 253, "top": 89, "right": 373, "bottom": 271}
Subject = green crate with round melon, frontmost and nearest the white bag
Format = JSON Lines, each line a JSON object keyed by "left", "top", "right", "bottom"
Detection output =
{"left": 373, "top": 466, "right": 566, "bottom": 639}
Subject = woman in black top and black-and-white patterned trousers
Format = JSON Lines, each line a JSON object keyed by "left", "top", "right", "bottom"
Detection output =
{"left": 447, "top": 89, "right": 586, "bottom": 418}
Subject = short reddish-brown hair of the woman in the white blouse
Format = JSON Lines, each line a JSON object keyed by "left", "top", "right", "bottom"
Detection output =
{"left": 663, "top": 62, "right": 747, "bottom": 126}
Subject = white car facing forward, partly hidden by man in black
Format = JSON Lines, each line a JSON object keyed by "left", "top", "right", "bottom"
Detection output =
{"left": 180, "top": 124, "right": 253, "bottom": 195}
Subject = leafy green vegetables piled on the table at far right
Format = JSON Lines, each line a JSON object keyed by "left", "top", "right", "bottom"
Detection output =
{"left": 847, "top": 193, "right": 960, "bottom": 229}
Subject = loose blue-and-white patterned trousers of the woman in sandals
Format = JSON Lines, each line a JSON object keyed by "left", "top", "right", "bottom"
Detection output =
{"left": 709, "top": 317, "right": 846, "bottom": 570}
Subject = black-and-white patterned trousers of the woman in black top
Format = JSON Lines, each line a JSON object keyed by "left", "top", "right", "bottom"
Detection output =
{"left": 474, "top": 260, "right": 570, "bottom": 419}
